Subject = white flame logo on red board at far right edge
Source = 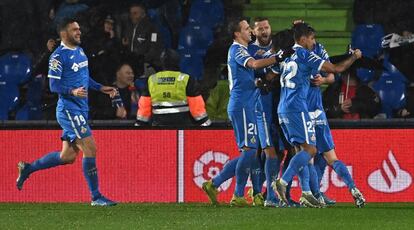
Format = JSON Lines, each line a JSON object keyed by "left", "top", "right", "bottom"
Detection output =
{"left": 368, "top": 150, "right": 412, "bottom": 193}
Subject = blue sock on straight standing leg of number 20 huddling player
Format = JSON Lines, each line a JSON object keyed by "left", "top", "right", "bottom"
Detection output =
{"left": 234, "top": 149, "right": 256, "bottom": 197}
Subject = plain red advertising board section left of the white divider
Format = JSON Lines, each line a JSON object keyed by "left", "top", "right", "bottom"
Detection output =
{"left": 0, "top": 130, "right": 177, "bottom": 202}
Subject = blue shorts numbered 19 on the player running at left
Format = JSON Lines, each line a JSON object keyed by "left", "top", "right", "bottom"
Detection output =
{"left": 56, "top": 110, "right": 92, "bottom": 142}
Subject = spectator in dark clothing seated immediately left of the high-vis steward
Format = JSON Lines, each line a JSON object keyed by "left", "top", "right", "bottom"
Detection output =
{"left": 90, "top": 63, "right": 138, "bottom": 119}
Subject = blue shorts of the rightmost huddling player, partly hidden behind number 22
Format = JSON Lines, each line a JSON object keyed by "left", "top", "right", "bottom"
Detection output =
{"left": 309, "top": 110, "right": 335, "bottom": 153}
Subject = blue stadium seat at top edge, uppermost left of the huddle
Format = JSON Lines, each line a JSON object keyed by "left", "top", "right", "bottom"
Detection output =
{"left": 188, "top": 0, "right": 224, "bottom": 28}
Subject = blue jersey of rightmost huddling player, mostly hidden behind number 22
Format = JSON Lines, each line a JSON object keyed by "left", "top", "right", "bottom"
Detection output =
{"left": 308, "top": 43, "right": 329, "bottom": 111}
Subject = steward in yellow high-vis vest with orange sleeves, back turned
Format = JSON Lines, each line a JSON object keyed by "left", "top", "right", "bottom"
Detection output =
{"left": 136, "top": 50, "right": 211, "bottom": 126}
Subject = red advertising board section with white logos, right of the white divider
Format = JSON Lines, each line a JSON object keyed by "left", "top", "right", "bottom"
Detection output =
{"left": 184, "top": 129, "right": 414, "bottom": 202}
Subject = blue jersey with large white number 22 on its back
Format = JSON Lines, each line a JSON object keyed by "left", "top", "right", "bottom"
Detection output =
{"left": 278, "top": 44, "right": 324, "bottom": 113}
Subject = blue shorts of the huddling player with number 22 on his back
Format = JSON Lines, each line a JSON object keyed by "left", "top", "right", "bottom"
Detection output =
{"left": 278, "top": 112, "right": 316, "bottom": 146}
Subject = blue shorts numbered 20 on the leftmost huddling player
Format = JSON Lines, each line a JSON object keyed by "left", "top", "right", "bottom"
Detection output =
{"left": 228, "top": 109, "right": 258, "bottom": 149}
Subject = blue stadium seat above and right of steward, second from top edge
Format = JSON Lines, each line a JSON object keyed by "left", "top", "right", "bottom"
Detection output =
{"left": 178, "top": 24, "right": 214, "bottom": 53}
